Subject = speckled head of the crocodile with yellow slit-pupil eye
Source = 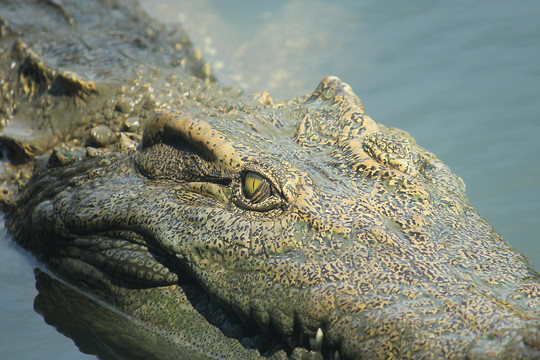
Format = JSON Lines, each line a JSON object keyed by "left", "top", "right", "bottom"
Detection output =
{"left": 8, "top": 77, "right": 540, "bottom": 359}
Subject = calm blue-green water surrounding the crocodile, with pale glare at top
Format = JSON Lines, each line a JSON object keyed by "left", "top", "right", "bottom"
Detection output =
{"left": 0, "top": 0, "right": 540, "bottom": 359}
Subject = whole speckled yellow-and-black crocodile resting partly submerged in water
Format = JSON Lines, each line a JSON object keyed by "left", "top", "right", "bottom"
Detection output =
{"left": 0, "top": 1, "right": 540, "bottom": 359}
